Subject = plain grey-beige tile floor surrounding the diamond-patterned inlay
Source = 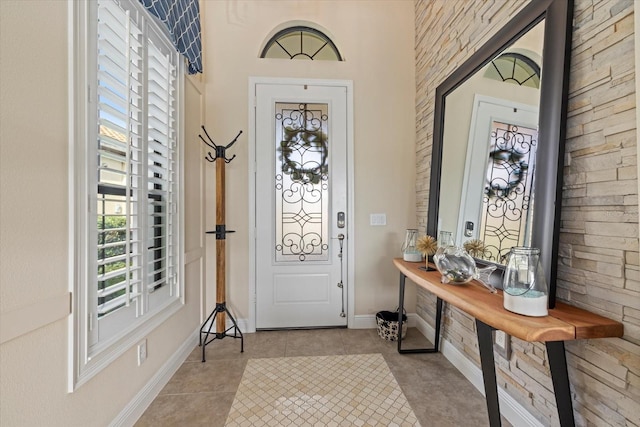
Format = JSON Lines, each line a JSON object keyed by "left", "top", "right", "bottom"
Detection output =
{"left": 136, "top": 328, "right": 509, "bottom": 427}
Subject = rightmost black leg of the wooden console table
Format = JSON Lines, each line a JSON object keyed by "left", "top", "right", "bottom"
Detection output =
{"left": 545, "top": 341, "right": 576, "bottom": 427}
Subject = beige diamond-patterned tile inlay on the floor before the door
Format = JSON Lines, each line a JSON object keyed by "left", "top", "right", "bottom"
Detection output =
{"left": 226, "top": 354, "right": 420, "bottom": 427}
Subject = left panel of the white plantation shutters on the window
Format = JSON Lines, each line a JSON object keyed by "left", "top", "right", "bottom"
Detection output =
{"left": 97, "top": 1, "right": 144, "bottom": 339}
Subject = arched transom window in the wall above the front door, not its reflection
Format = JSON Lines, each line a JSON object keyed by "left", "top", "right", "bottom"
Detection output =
{"left": 260, "top": 26, "right": 343, "bottom": 61}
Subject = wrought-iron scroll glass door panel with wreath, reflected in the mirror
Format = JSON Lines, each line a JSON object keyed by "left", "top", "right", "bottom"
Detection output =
{"left": 479, "top": 121, "right": 538, "bottom": 263}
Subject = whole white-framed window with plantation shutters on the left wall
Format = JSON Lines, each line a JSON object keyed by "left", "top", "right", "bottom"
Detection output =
{"left": 73, "top": 0, "right": 184, "bottom": 387}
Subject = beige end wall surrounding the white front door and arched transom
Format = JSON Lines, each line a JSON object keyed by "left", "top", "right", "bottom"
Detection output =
{"left": 203, "top": 1, "right": 416, "bottom": 319}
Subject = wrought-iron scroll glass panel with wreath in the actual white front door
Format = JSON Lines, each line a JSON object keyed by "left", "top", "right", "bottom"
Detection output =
{"left": 274, "top": 102, "right": 330, "bottom": 262}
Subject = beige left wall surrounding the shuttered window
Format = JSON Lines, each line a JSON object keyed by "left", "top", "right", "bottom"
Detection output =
{"left": 0, "top": 0, "right": 204, "bottom": 427}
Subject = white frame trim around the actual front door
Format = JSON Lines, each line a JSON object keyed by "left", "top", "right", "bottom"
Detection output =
{"left": 246, "top": 76, "right": 355, "bottom": 332}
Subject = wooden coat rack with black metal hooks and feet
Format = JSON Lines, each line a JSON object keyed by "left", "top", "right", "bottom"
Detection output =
{"left": 198, "top": 126, "right": 244, "bottom": 362}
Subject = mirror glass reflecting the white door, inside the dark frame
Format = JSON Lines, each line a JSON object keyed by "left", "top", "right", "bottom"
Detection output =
{"left": 438, "top": 20, "right": 544, "bottom": 265}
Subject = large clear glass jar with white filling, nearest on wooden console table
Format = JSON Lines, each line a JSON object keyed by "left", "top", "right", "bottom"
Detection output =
{"left": 502, "top": 246, "right": 549, "bottom": 317}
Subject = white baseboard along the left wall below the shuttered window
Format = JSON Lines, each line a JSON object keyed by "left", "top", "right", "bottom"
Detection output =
{"left": 109, "top": 327, "right": 200, "bottom": 427}
